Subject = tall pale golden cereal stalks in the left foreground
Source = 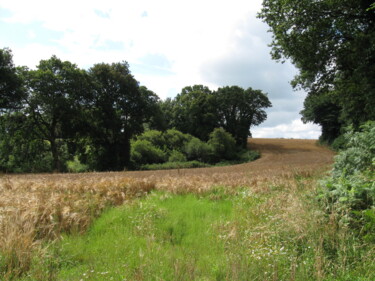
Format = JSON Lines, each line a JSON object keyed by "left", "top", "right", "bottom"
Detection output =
{"left": 0, "top": 176, "right": 155, "bottom": 280}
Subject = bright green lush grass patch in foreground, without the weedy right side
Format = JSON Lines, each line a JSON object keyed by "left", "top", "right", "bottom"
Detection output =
{"left": 55, "top": 189, "right": 233, "bottom": 280}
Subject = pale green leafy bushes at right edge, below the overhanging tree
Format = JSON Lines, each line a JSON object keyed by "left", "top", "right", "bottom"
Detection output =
{"left": 320, "top": 121, "right": 375, "bottom": 240}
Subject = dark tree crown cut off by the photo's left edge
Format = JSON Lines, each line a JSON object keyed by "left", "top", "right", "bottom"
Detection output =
{"left": 0, "top": 48, "right": 23, "bottom": 112}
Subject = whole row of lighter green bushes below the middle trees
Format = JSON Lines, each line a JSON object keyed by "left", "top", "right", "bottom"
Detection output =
{"left": 131, "top": 128, "right": 259, "bottom": 169}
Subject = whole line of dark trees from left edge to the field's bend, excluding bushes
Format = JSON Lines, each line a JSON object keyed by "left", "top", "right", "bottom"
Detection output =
{"left": 0, "top": 48, "right": 271, "bottom": 172}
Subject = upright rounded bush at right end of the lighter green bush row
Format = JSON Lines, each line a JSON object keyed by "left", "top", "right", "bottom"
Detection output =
{"left": 208, "top": 128, "right": 236, "bottom": 160}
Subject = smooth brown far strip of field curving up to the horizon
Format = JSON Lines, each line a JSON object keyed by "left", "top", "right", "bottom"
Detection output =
{"left": 2, "top": 139, "right": 334, "bottom": 189}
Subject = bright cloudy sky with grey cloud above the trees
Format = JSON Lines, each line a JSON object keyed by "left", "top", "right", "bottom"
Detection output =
{"left": 0, "top": 0, "right": 321, "bottom": 139}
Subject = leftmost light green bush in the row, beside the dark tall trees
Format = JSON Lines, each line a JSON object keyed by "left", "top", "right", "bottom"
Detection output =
{"left": 130, "top": 140, "right": 167, "bottom": 165}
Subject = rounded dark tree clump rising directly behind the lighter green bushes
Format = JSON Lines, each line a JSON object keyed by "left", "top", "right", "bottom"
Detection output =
{"left": 162, "top": 85, "right": 271, "bottom": 143}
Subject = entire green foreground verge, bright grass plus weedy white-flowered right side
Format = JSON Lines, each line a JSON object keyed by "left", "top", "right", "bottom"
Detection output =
{"left": 19, "top": 183, "right": 375, "bottom": 280}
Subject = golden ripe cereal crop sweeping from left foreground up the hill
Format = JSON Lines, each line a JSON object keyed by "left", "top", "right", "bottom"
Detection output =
{"left": 0, "top": 139, "right": 333, "bottom": 279}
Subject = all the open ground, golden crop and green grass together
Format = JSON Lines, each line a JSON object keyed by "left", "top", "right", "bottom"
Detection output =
{"left": 0, "top": 139, "right": 375, "bottom": 280}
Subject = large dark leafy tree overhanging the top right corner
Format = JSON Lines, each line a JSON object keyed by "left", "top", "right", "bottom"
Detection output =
{"left": 259, "top": 0, "right": 375, "bottom": 142}
